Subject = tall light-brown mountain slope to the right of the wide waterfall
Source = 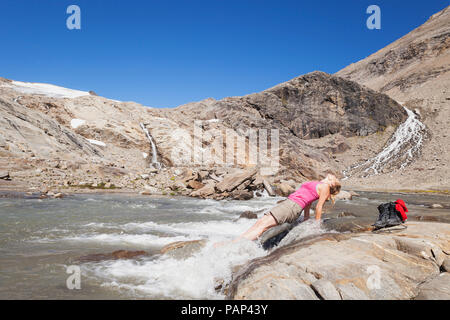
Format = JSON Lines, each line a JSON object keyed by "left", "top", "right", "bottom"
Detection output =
{"left": 336, "top": 7, "right": 450, "bottom": 190}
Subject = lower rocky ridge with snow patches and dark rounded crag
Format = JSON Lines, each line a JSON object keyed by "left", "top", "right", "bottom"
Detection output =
{"left": 0, "top": 72, "right": 407, "bottom": 197}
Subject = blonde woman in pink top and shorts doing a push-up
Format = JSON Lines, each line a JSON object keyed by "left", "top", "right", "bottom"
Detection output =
{"left": 234, "top": 174, "right": 341, "bottom": 241}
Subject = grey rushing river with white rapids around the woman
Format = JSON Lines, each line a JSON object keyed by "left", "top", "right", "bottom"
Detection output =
{"left": 0, "top": 193, "right": 450, "bottom": 299}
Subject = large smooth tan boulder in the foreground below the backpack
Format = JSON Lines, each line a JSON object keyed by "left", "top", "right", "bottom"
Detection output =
{"left": 228, "top": 222, "right": 450, "bottom": 300}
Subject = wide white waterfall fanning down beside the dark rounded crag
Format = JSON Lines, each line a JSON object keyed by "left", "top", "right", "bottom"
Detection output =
{"left": 344, "top": 107, "right": 425, "bottom": 178}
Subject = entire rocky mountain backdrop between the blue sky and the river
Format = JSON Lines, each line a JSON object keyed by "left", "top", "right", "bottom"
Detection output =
{"left": 0, "top": 8, "right": 450, "bottom": 195}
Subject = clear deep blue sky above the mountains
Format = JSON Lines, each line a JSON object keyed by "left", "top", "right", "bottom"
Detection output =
{"left": 0, "top": 0, "right": 449, "bottom": 107}
